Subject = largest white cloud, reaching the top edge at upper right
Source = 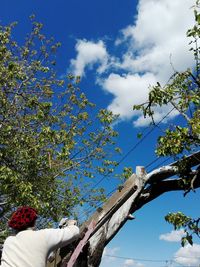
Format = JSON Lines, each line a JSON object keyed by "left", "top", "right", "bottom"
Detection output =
{"left": 117, "top": 0, "right": 194, "bottom": 82}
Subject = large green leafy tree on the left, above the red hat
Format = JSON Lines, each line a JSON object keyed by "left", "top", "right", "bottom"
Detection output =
{"left": 0, "top": 16, "right": 119, "bottom": 230}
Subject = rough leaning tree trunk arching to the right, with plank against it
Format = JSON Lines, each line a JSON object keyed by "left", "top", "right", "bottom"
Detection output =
{"left": 48, "top": 152, "right": 200, "bottom": 267}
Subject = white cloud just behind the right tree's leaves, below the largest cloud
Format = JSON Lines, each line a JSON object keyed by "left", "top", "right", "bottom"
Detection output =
{"left": 102, "top": 73, "right": 177, "bottom": 127}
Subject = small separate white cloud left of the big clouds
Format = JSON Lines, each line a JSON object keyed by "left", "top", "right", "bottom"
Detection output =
{"left": 70, "top": 39, "right": 108, "bottom": 76}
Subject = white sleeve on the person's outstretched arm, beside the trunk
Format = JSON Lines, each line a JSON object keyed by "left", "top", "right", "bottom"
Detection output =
{"left": 44, "top": 225, "right": 80, "bottom": 251}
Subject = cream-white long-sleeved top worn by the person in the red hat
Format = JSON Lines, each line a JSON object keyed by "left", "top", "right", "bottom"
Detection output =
{"left": 1, "top": 225, "right": 79, "bottom": 267}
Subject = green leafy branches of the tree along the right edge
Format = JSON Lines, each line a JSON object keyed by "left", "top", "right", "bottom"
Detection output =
{"left": 133, "top": 1, "right": 200, "bottom": 245}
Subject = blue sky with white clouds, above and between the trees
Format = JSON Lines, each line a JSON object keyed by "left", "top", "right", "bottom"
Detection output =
{"left": 0, "top": 0, "right": 200, "bottom": 267}
